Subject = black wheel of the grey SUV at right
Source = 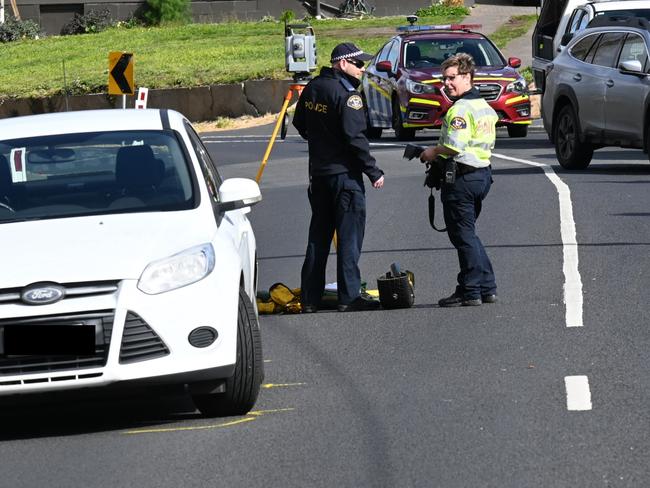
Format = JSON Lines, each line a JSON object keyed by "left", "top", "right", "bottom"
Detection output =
{"left": 553, "top": 105, "right": 594, "bottom": 169}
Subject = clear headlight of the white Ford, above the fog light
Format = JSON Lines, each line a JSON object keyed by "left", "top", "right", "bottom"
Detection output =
{"left": 138, "top": 244, "right": 214, "bottom": 295}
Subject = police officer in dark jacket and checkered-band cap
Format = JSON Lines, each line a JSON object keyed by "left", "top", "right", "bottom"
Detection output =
{"left": 293, "top": 43, "right": 384, "bottom": 313}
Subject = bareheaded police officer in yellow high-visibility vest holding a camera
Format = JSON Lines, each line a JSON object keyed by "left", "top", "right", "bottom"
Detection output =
{"left": 420, "top": 53, "right": 498, "bottom": 307}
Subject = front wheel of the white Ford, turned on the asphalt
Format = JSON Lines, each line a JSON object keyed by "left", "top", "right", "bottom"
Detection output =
{"left": 192, "top": 288, "right": 264, "bottom": 417}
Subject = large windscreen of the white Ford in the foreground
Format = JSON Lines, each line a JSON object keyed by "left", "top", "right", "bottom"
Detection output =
{"left": 0, "top": 131, "right": 195, "bottom": 223}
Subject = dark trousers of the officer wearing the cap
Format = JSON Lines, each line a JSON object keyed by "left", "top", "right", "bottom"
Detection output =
{"left": 300, "top": 173, "right": 366, "bottom": 305}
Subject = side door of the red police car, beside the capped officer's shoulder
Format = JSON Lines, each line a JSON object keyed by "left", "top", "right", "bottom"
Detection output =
{"left": 363, "top": 40, "right": 396, "bottom": 128}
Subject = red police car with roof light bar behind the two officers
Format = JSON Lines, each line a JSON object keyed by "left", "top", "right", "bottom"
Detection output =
{"left": 362, "top": 18, "right": 531, "bottom": 140}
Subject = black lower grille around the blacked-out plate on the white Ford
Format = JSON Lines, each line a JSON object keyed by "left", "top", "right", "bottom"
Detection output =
{"left": 0, "top": 310, "right": 114, "bottom": 378}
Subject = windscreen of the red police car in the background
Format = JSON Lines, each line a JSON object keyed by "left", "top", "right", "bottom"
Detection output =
{"left": 404, "top": 37, "right": 505, "bottom": 69}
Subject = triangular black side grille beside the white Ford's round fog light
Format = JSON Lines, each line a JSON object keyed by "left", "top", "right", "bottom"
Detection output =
{"left": 120, "top": 312, "right": 169, "bottom": 364}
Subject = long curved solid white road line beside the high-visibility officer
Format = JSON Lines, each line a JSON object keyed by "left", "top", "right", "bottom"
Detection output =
{"left": 492, "top": 153, "right": 583, "bottom": 327}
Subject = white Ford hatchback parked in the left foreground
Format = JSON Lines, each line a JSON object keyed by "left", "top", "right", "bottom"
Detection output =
{"left": 0, "top": 110, "right": 263, "bottom": 416}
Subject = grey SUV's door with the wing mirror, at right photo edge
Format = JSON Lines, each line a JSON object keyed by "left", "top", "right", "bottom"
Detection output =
{"left": 605, "top": 33, "right": 650, "bottom": 145}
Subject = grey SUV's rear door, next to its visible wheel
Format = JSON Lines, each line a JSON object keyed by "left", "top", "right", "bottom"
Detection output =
{"left": 569, "top": 32, "right": 625, "bottom": 140}
